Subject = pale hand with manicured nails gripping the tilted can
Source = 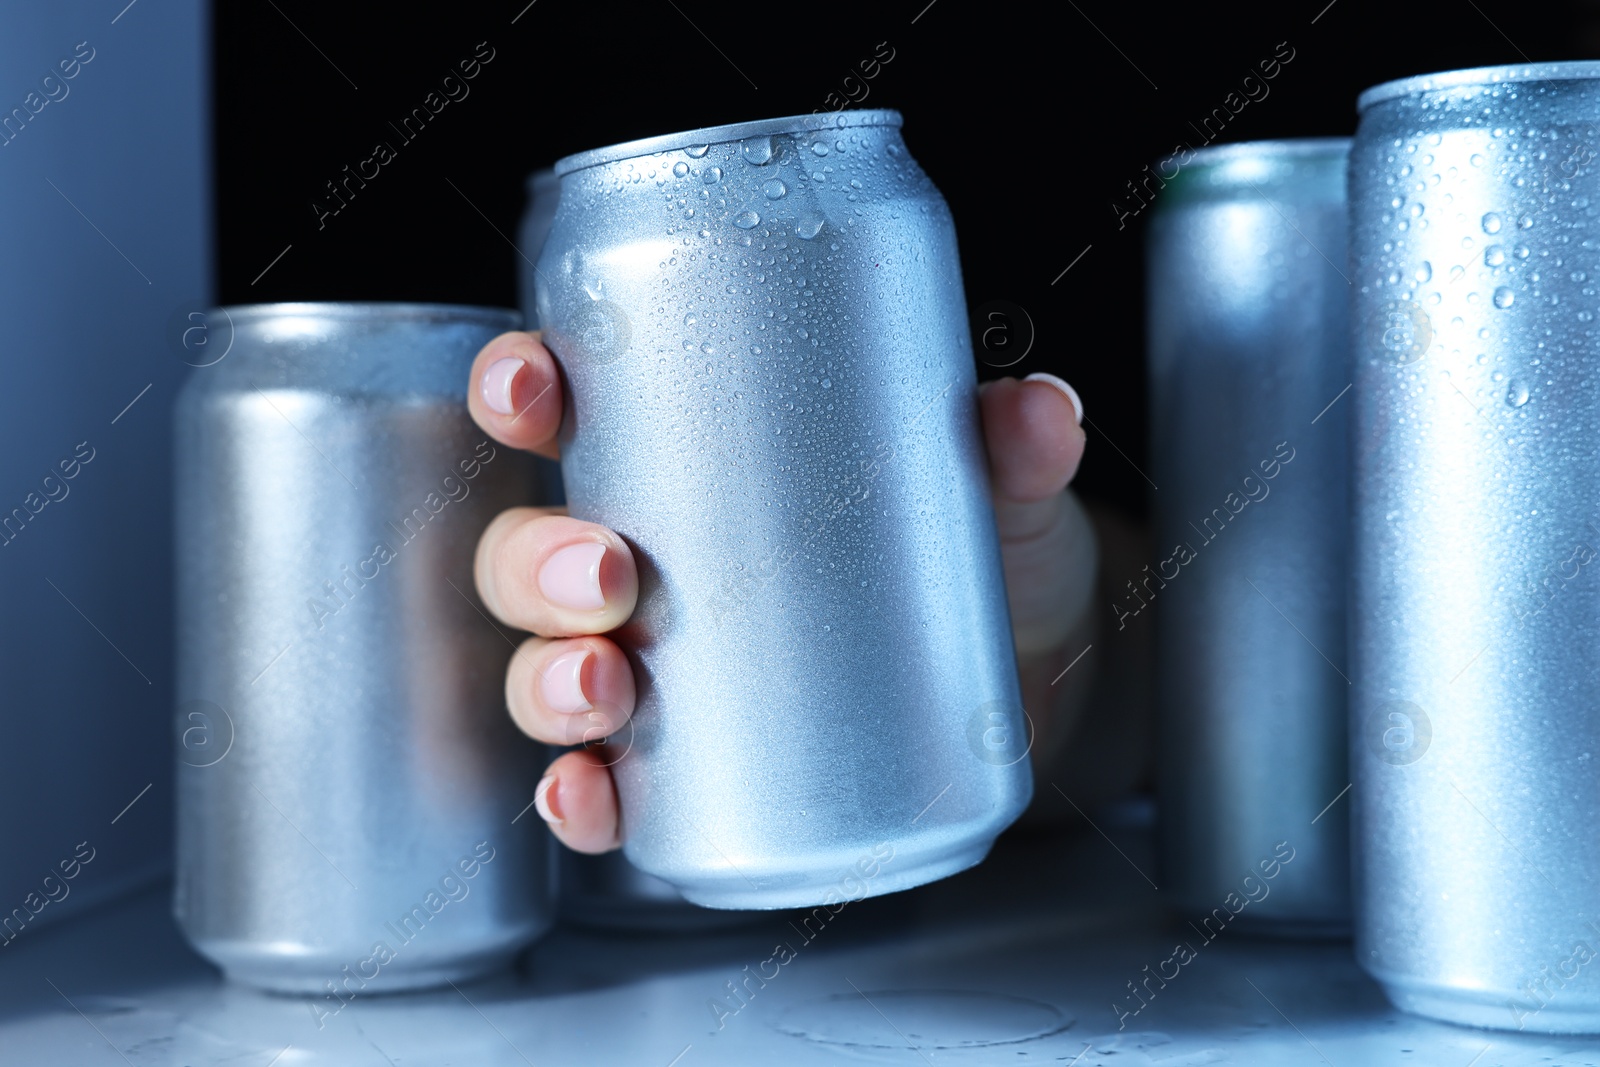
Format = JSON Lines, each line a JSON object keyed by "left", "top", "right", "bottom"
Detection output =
{"left": 467, "top": 333, "right": 1094, "bottom": 853}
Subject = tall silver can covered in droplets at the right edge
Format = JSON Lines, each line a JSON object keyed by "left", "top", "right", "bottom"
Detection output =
{"left": 1350, "top": 62, "right": 1600, "bottom": 1033}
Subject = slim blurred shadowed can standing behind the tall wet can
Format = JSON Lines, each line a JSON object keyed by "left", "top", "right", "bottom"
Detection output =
{"left": 1145, "top": 139, "right": 1350, "bottom": 936}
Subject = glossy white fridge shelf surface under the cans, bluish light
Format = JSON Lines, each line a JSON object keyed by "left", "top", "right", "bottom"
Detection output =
{"left": 0, "top": 825, "right": 1600, "bottom": 1067}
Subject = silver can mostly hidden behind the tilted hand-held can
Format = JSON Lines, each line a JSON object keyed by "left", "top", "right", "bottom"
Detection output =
{"left": 517, "top": 170, "right": 731, "bottom": 931}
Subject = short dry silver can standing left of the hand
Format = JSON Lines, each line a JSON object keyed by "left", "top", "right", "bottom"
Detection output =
{"left": 174, "top": 304, "right": 549, "bottom": 991}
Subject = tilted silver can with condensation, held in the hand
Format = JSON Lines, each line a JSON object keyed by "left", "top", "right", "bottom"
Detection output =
{"left": 538, "top": 112, "right": 1032, "bottom": 909}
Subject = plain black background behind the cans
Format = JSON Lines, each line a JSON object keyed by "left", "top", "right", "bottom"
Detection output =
{"left": 214, "top": 0, "right": 1580, "bottom": 512}
